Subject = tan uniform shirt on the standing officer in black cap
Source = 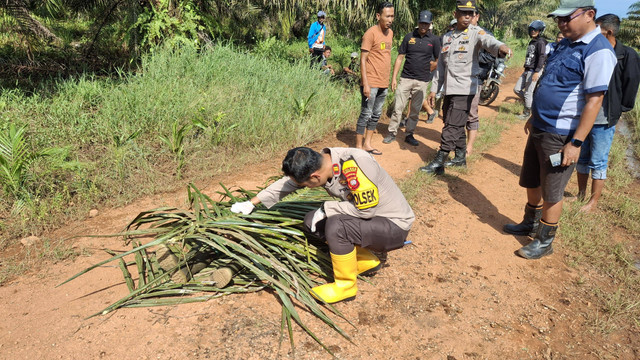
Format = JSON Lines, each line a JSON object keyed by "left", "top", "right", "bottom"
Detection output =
{"left": 431, "top": 25, "right": 503, "bottom": 95}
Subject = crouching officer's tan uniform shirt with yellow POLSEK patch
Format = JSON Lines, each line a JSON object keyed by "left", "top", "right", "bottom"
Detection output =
{"left": 257, "top": 148, "right": 415, "bottom": 231}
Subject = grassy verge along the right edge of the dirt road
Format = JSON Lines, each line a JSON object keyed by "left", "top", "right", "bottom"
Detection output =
{"left": 559, "top": 128, "right": 640, "bottom": 334}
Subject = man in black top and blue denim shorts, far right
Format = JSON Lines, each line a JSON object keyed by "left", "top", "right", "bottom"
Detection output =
{"left": 576, "top": 14, "right": 640, "bottom": 211}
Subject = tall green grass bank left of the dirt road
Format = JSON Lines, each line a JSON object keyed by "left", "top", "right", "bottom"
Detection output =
{"left": 0, "top": 45, "right": 359, "bottom": 245}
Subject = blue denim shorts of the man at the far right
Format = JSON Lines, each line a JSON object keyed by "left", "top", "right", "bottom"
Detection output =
{"left": 576, "top": 125, "right": 616, "bottom": 180}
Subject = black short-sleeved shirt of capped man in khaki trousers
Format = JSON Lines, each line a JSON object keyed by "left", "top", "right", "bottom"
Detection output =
{"left": 398, "top": 29, "right": 440, "bottom": 82}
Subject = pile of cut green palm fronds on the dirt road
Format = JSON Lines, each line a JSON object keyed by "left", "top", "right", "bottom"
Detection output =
{"left": 61, "top": 185, "right": 356, "bottom": 353}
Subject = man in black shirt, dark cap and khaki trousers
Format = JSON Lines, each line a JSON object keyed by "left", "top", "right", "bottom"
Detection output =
{"left": 382, "top": 10, "right": 440, "bottom": 146}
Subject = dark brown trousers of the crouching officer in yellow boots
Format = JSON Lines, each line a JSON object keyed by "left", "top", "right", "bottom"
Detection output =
{"left": 304, "top": 210, "right": 409, "bottom": 255}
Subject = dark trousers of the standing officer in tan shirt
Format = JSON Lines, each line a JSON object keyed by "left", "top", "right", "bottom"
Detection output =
{"left": 440, "top": 95, "right": 474, "bottom": 151}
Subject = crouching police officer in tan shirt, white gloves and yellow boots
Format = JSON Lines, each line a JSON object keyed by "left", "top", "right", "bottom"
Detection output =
{"left": 231, "top": 147, "right": 415, "bottom": 303}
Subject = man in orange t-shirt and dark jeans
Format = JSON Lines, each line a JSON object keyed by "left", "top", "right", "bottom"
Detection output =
{"left": 356, "top": 2, "right": 394, "bottom": 155}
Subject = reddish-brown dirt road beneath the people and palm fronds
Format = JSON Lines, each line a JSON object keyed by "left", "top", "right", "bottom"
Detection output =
{"left": 0, "top": 72, "right": 640, "bottom": 360}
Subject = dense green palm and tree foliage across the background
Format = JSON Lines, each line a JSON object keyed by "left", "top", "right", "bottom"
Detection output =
{"left": 0, "top": 0, "right": 568, "bottom": 68}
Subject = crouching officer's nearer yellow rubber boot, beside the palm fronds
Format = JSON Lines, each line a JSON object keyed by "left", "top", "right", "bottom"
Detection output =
{"left": 311, "top": 249, "right": 358, "bottom": 304}
